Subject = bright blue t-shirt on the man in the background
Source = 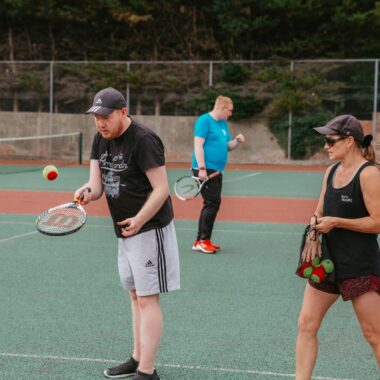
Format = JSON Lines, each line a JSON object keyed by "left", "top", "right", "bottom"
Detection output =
{"left": 191, "top": 113, "right": 231, "bottom": 171}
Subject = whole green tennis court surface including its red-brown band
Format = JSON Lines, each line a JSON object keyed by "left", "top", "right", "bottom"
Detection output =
{"left": 0, "top": 165, "right": 379, "bottom": 380}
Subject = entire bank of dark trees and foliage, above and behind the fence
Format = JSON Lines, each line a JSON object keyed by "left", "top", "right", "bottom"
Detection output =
{"left": 0, "top": 0, "right": 380, "bottom": 158}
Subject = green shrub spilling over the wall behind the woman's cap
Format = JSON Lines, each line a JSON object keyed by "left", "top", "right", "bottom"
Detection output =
{"left": 261, "top": 64, "right": 352, "bottom": 159}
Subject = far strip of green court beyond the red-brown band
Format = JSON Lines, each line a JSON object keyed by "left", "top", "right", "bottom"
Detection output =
{"left": 0, "top": 165, "right": 323, "bottom": 198}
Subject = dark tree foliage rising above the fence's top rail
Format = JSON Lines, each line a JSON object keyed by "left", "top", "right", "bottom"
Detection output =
{"left": 0, "top": 0, "right": 380, "bottom": 61}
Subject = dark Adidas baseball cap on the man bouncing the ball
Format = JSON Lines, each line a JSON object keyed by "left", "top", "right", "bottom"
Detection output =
{"left": 85, "top": 87, "right": 127, "bottom": 116}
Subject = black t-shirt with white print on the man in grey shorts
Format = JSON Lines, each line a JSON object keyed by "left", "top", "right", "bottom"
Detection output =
{"left": 90, "top": 119, "right": 173, "bottom": 237}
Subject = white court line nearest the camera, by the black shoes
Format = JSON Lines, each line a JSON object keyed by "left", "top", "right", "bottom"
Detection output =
{"left": 0, "top": 352, "right": 354, "bottom": 380}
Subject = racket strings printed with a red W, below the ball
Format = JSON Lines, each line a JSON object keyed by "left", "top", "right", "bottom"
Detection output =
{"left": 37, "top": 207, "right": 87, "bottom": 234}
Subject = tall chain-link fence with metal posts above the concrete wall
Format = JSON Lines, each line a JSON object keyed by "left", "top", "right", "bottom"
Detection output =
{"left": 0, "top": 59, "right": 379, "bottom": 157}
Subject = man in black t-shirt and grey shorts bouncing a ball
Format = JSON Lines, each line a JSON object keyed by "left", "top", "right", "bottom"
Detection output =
{"left": 75, "top": 88, "right": 180, "bottom": 380}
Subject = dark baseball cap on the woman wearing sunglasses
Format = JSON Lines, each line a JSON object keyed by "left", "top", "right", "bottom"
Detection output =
{"left": 314, "top": 115, "right": 364, "bottom": 142}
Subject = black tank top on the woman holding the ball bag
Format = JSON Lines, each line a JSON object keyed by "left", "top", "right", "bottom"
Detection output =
{"left": 323, "top": 162, "right": 380, "bottom": 280}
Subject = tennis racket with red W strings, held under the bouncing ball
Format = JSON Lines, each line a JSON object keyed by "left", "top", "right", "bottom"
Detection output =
{"left": 36, "top": 187, "right": 91, "bottom": 236}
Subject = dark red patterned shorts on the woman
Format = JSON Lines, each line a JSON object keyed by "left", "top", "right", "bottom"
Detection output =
{"left": 309, "top": 275, "right": 380, "bottom": 301}
